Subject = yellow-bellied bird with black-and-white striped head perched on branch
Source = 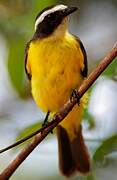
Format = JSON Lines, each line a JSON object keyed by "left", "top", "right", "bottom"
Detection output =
{"left": 25, "top": 4, "right": 90, "bottom": 177}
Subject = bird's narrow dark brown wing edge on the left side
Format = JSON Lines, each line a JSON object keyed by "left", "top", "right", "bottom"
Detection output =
{"left": 25, "top": 41, "right": 31, "bottom": 80}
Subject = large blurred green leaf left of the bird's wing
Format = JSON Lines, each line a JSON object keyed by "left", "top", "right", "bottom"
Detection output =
{"left": 8, "top": 38, "right": 25, "bottom": 95}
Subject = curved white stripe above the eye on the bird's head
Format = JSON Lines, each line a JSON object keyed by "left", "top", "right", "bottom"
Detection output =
{"left": 35, "top": 4, "right": 67, "bottom": 31}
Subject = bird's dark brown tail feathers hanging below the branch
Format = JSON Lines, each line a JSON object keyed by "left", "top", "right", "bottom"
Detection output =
{"left": 57, "top": 125, "right": 90, "bottom": 177}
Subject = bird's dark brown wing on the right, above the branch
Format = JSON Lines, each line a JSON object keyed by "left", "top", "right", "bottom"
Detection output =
{"left": 74, "top": 36, "right": 88, "bottom": 77}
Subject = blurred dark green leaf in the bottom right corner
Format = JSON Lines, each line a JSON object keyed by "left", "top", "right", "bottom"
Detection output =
{"left": 93, "top": 135, "right": 117, "bottom": 166}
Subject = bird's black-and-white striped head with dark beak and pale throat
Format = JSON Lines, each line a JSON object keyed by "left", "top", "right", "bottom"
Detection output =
{"left": 33, "top": 5, "right": 77, "bottom": 39}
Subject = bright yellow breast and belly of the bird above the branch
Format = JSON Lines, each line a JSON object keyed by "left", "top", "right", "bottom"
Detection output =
{"left": 28, "top": 35, "right": 84, "bottom": 112}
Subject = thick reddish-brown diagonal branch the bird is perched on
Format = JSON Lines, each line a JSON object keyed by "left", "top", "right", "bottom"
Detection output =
{"left": 0, "top": 42, "right": 117, "bottom": 180}
